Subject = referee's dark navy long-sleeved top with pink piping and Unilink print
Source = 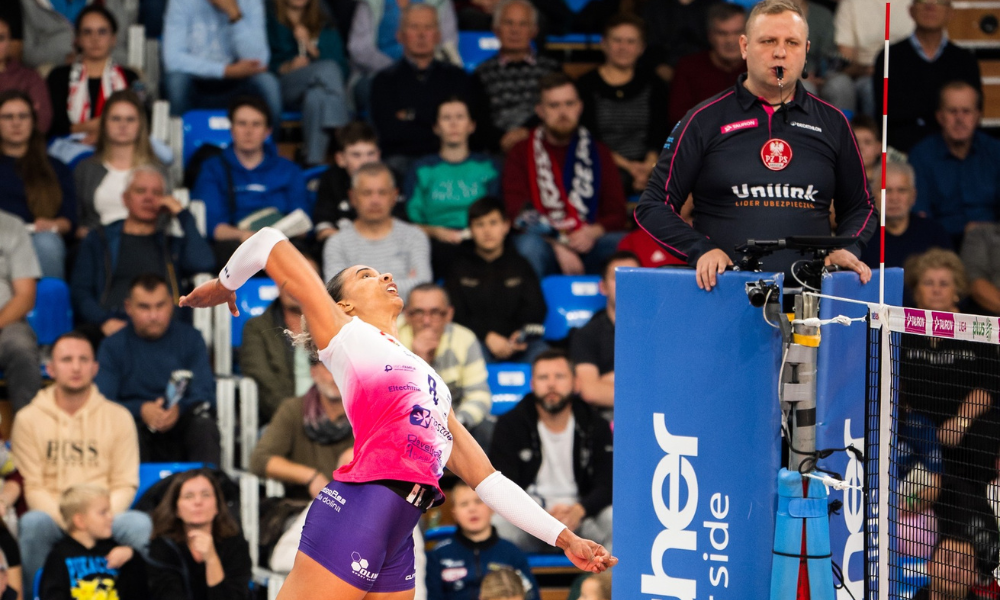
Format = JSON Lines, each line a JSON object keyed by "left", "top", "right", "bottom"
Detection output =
{"left": 635, "top": 74, "right": 879, "bottom": 273}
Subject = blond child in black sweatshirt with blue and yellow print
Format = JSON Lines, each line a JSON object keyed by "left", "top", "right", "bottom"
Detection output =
{"left": 38, "top": 484, "right": 149, "bottom": 600}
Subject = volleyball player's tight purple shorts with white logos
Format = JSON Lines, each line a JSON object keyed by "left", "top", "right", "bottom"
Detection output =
{"left": 299, "top": 481, "right": 422, "bottom": 592}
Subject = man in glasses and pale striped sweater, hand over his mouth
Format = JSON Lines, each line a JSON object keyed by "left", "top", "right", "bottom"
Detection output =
{"left": 394, "top": 283, "right": 495, "bottom": 448}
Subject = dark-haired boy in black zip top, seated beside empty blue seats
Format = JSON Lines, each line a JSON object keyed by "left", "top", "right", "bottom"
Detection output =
{"left": 444, "top": 196, "right": 548, "bottom": 362}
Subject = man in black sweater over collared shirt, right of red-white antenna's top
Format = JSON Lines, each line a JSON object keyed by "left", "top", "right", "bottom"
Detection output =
{"left": 872, "top": 0, "right": 982, "bottom": 152}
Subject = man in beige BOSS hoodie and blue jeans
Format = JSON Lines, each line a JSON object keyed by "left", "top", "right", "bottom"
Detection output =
{"left": 11, "top": 331, "right": 153, "bottom": 598}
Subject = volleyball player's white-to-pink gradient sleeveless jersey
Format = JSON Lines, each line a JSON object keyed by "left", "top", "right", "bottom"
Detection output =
{"left": 319, "top": 317, "right": 452, "bottom": 496}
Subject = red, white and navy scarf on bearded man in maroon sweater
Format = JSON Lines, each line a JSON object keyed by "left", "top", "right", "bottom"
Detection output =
{"left": 528, "top": 127, "right": 599, "bottom": 232}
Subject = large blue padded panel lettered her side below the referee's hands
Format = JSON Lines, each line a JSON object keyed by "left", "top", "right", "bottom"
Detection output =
{"left": 613, "top": 268, "right": 781, "bottom": 600}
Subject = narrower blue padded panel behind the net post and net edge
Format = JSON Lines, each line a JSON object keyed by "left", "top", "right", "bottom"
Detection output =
{"left": 816, "top": 268, "right": 903, "bottom": 600}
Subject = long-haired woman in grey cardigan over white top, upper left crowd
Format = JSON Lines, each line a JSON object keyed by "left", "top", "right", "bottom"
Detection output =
{"left": 73, "top": 90, "right": 170, "bottom": 239}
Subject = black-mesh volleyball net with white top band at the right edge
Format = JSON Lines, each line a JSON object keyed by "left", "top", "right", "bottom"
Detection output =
{"left": 858, "top": 305, "right": 1000, "bottom": 600}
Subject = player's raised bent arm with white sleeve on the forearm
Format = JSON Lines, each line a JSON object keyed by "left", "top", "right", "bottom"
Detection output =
{"left": 179, "top": 227, "right": 350, "bottom": 348}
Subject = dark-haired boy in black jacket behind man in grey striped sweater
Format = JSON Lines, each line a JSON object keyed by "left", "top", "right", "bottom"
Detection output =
{"left": 313, "top": 121, "right": 406, "bottom": 245}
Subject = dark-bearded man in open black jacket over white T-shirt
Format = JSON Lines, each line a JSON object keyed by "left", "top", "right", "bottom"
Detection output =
{"left": 489, "top": 350, "right": 612, "bottom": 552}
